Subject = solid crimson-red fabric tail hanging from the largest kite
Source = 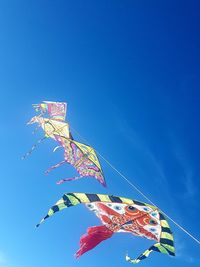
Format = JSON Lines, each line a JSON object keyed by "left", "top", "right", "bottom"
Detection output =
{"left": 75, "top": 225, "right": 113, "bottom": 258}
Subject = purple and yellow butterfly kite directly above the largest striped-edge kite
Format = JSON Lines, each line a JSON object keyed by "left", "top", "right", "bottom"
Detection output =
{"left": 46, "top": 135, "right": 106, "bottom": 187}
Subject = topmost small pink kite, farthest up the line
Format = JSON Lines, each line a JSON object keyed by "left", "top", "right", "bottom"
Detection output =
{"left": 33, "top": 101, "right": 67, "bottom": 121}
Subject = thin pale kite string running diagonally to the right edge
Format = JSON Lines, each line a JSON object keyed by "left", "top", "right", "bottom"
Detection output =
{"left": 71, "top": 127, "right": 200, "bottom": 245}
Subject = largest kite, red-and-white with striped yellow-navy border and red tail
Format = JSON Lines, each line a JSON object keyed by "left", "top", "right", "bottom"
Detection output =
{"left": 37, "top": 193, "right": 175, "bottom": 263}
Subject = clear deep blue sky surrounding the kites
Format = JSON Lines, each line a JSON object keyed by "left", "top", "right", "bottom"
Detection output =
{"left": 0, "top": 0, "right": 200, "bottom": 267}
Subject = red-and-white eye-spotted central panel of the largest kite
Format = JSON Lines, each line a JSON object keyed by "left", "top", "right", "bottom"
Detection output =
{"left": 87, "top": 202, "right": 161, "bottom": 241}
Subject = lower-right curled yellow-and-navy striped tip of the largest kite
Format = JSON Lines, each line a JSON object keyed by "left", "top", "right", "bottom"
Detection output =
{"left": 126, "top": 243, "right": 175, "bottom": 263}
